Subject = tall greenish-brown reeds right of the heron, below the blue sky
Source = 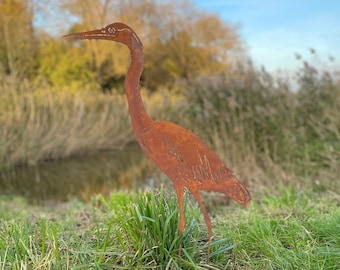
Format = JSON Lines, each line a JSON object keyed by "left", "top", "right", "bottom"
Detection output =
{"left": 175, "top": 59, "right": 340, "bottom": 189}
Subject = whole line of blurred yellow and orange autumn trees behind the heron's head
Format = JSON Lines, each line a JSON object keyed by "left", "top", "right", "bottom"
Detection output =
{"left": 0, "top": 0, "right": 244, "bottom": 91}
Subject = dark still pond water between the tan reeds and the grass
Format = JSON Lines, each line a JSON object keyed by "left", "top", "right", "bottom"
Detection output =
{"left": 0, "top": 143, "right": 163, "bottom": 203}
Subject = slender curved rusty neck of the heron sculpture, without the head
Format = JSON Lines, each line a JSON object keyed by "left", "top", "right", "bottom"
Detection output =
{"left": 125, "top": 46, "right": 152, "bottom": 133}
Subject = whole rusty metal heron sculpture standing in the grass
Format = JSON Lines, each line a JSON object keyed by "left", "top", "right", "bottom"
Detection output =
{"left": 65, "top": 23, "right": 251, "bottom": 259}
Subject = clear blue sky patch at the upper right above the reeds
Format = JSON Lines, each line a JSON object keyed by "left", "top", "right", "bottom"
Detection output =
{"left": 192, "top": 0, "right": 340, "bottom": 72}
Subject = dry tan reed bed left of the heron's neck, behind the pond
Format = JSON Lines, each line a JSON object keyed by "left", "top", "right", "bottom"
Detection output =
{"left": 0, "top": 85, "right": 133, "bottom": 167}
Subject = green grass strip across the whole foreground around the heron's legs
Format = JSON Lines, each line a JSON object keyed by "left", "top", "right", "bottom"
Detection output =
{"left": 0, "top": 188, "right": 340, "bottom": 269}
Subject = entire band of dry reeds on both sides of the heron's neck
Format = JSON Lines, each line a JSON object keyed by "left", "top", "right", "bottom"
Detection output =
{"left": 0, "top": 58, "right": 340, "bottom": 190}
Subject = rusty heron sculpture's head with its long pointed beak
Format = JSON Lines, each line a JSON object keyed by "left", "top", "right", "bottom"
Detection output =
{"left": 64, "top": 22, "right": 143, "bottom": 48}
